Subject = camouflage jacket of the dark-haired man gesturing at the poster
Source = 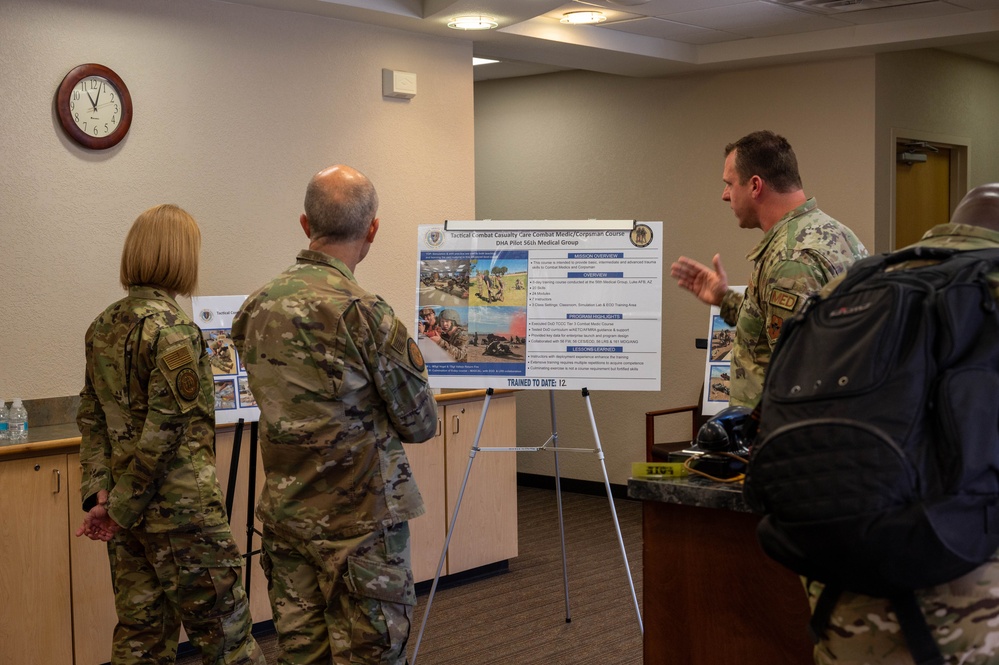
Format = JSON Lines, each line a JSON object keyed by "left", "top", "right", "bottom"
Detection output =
{"left": 721, "top": 199, "right": 867, "bottom": 408}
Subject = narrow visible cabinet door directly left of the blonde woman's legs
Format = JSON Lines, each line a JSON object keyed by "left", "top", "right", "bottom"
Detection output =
{"left": 66, "top": 453, "right": 118, "bottom": 665}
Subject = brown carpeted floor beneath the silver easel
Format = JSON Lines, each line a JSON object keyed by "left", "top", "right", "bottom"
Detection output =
{"left": 177, "top": 487, "right": 642, "bottom": 665}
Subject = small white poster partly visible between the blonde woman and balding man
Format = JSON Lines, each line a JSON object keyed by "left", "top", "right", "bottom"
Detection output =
{"left": 191, "top": 296, "right": 260, "bottom": 425}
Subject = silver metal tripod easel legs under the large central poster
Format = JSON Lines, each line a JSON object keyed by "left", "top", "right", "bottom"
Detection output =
{"left": 411, "top": 388, "right": 645, "bottom": 665}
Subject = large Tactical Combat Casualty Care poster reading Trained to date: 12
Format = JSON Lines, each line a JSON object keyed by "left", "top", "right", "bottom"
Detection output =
{"left": 413, "top": 220, "right": 663, "bottom": 391}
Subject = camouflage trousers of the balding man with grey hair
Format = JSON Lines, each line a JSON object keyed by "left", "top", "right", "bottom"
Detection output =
{"left": 261, "top": 522, "right": 416, "bottom": 665}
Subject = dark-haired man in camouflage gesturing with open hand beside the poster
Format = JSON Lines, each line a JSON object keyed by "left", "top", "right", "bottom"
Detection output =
{"left": 671, "top": 131, "right": 867, "bottom": 407}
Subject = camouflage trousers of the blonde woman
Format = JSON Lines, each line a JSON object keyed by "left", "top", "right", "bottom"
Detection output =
{"left": 108, "top": 526, "right": 266, "bottom": 665}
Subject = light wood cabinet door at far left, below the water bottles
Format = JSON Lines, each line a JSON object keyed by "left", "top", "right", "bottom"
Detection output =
{"left": 0, "top": 455, "right": 73, "bottom": 665}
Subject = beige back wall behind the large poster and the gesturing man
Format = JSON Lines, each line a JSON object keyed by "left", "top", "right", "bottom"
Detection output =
{"left": 475, "top": 57, "right": 875, "bottom": 483}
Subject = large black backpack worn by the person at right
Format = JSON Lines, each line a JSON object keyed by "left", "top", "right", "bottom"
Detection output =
{"left": 744, "top": 248, "right": 999, "bottom": 663}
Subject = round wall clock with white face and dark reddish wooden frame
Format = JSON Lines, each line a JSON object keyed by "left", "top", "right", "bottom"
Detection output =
{"left": 56, "top": 63, "right": 132, "bottom": 150}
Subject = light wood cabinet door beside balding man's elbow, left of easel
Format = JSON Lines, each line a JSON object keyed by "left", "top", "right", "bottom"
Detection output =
{"left": 403, "top": 418, "right": 448, "bottom": 582}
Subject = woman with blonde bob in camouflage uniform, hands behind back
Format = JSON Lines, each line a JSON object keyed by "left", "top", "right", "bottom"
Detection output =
{"left": 77, "top": 206, "right": 265, "bottom": 665}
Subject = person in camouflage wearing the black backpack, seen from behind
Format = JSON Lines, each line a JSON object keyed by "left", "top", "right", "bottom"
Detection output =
{"left": 806, "top": 183, "right": 999, "bottom": 665}
